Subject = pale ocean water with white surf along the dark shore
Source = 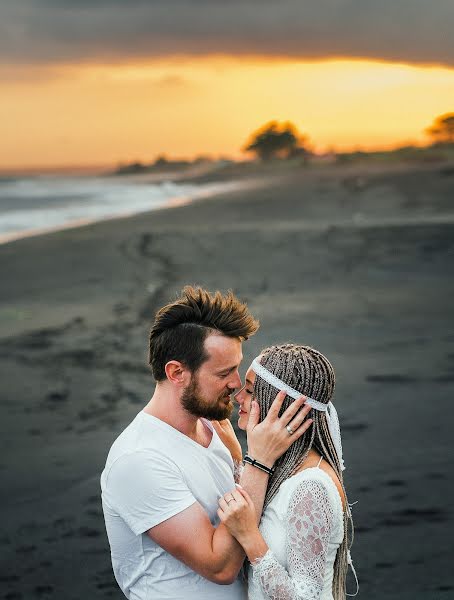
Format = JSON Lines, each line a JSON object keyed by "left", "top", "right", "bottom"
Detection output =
{"left": 0, "top": 175, "right": 238, "bottom": 243}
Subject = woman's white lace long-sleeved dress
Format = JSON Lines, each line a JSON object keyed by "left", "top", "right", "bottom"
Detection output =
{"left": 248, "top": 467, "right": 344, "bottom": 600}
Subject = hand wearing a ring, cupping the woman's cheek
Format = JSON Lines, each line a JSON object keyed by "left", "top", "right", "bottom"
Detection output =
{"left": 246, "top": 392, "right": 312, "bottom": 467}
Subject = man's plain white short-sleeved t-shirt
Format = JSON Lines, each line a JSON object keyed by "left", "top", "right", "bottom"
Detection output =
{"left": 101, "top": 411, "right": 245, "bottom": 600}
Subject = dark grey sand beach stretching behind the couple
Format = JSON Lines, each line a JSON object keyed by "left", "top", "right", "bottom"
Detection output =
{"left": 0, "top": 165, "right": 454, "bottom": 600}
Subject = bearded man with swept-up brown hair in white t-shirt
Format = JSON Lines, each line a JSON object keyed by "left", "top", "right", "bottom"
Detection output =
{"left": 101, "top": 287, "right": 310, "bottom": 600}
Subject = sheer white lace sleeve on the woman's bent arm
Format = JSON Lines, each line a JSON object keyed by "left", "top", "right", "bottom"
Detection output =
{"left": 252, "top": 480, "right": 334, "bottom": 600}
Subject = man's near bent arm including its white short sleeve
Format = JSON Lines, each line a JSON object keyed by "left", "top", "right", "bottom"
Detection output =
{"left": 103, "top": 449, "right": 248, "bottom": 584}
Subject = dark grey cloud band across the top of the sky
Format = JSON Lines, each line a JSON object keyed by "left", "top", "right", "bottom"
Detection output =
{"left": 0, "top": 0, "right": 454, "bottom": 66}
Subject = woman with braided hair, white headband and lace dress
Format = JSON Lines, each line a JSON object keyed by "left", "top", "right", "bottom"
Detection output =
{"left": 218, "top": 344, "right": 351, "bottom": 600}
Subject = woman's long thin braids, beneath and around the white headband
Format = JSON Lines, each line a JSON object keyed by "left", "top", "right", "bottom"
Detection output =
{"left": 254, "top": 344, "right": 353, "bottom": 600}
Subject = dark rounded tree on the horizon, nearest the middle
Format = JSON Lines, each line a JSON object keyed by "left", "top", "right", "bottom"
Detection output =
{"left": 243, "top": 121, "right": 309, "bottom": 161}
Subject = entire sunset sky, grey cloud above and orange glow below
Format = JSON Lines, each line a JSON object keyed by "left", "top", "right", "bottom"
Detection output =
{"left": 0, "top": 0, "right": 454, "bottom": 169}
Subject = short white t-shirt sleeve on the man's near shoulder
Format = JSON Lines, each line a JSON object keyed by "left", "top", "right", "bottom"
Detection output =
{"left": 103, "top": 450, "right": 196, "bottom": 535}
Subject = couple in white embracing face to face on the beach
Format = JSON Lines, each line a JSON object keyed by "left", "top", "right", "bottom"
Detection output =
{"left": 101, "top": 287, "right": 351, "bottom": 600}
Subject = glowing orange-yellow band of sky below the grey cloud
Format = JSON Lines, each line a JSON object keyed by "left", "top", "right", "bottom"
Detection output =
{"left": 0, "top": 56, "right": 454, "bottom": 168}
